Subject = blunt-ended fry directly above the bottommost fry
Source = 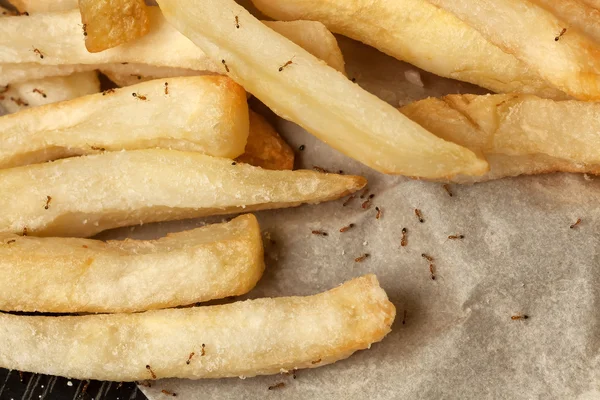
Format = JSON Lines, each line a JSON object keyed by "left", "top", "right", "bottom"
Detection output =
{"left": 0, "top": 215, "right": 264, "bottom": 313}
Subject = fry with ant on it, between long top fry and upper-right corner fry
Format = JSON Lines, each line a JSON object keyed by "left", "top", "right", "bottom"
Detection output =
{"left": 428, "top": 0, "right": 600, "bottom": 100}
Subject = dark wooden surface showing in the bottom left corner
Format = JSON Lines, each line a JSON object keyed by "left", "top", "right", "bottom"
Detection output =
{"left": 0, "top": 369, "right": 146, "bottom": 400}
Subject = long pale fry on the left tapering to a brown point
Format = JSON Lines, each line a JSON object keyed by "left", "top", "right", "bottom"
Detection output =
{"left": 0, "top": 150, "right": 366, "bottom": 237}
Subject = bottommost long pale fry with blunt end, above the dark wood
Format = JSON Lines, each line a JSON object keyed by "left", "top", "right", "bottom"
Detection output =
{"left": 0, "top": 275, "right": 396, "bottom": 381}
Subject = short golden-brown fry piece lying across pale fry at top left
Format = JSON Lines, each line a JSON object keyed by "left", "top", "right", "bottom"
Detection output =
{"left": 79, "top": 0, "right": 150, "bottom": 53}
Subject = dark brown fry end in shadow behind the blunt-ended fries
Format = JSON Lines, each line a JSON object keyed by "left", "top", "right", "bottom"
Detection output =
{"left": 236, "top": 111, "right": 294, "bottom": 170}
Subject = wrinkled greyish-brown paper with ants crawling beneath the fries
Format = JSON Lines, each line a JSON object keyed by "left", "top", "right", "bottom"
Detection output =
{"left": 126, "top": 32, "right": 600, "bottom": 400}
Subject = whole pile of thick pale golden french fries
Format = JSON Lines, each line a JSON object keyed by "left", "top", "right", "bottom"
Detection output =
{"left": 0, "top": 0, "right": 600, "bottom": 381}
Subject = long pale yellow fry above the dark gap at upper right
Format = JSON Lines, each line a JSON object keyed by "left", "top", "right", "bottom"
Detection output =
{"left": 252, "top": 0, "right": 566, "bottom": 98}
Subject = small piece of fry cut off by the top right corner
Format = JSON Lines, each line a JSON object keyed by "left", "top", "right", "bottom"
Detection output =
{"left": 531, "top": 0, "right": 600, "bottom": 44}
